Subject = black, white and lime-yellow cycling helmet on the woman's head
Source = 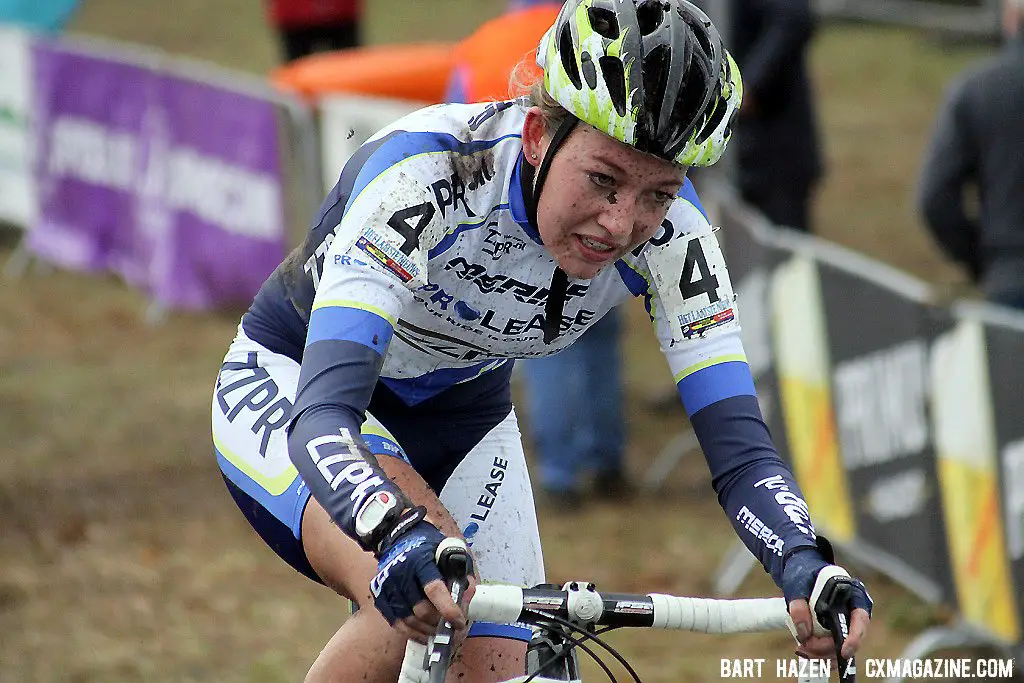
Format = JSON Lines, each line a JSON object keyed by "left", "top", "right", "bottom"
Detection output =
{"left": 537, "top": 0, "right": 743, "bottom": 166}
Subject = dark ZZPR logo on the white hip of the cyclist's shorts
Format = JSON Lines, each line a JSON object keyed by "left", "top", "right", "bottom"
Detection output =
{"left": 216, "top": 351, "right": 292, "bottom": 458}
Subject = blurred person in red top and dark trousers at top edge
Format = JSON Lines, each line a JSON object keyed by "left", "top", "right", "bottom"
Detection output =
{"left": 266, "top": 0, "right": 362, "bottom": 61}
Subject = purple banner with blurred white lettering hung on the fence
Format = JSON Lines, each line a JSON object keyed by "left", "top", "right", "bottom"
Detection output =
{"left": 29, "top": 44, "right": 285, "bottom": 308}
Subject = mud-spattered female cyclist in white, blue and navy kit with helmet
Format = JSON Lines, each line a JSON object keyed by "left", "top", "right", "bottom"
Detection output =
{"left": 207, "top": 0, "right": 870, "bottom": 682}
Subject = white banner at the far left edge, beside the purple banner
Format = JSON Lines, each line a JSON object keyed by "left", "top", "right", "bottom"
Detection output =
{"left": 0, "top": 27, "right": 36, "bottom": 227}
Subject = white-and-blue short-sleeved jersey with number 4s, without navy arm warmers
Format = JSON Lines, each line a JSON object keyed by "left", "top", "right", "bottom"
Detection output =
{"left": 250, "top": 102, "right": 743, "bottom": 398}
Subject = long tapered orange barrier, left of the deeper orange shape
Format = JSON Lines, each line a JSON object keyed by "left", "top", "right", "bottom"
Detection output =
{"left": 270, "top": 43, "right": 455, "bottom": 103}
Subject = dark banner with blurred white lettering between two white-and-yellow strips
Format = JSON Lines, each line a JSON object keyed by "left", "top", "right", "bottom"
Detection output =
{"left": 819, "top": 263, "right": 953, "bottom": 601}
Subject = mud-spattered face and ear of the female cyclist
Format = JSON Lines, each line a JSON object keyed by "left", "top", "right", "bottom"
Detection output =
{"left": 523, "top": 108, "right": 686, "bottom": 280}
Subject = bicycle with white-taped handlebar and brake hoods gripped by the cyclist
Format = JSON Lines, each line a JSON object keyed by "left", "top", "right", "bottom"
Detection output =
{"left": 398, "top": 539, "right": 856, "bottom": 683}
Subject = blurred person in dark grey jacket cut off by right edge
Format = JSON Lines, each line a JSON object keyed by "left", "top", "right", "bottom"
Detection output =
{"left": 918, "top": 0, "right": 1024, "bottom": 308}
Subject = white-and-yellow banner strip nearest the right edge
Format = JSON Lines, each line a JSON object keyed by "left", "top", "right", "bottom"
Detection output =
{"left": 931, "top": 321, "right": 1020, "bottom": 643}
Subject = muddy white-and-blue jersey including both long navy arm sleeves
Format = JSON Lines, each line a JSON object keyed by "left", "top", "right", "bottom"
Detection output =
{"left": 242, "top": 101, "right": 814, "bottom": 582}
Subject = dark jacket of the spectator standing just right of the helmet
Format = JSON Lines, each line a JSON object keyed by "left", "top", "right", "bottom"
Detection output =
{"left": 728, "top": 0, "right": 823, "bottom": 192}
